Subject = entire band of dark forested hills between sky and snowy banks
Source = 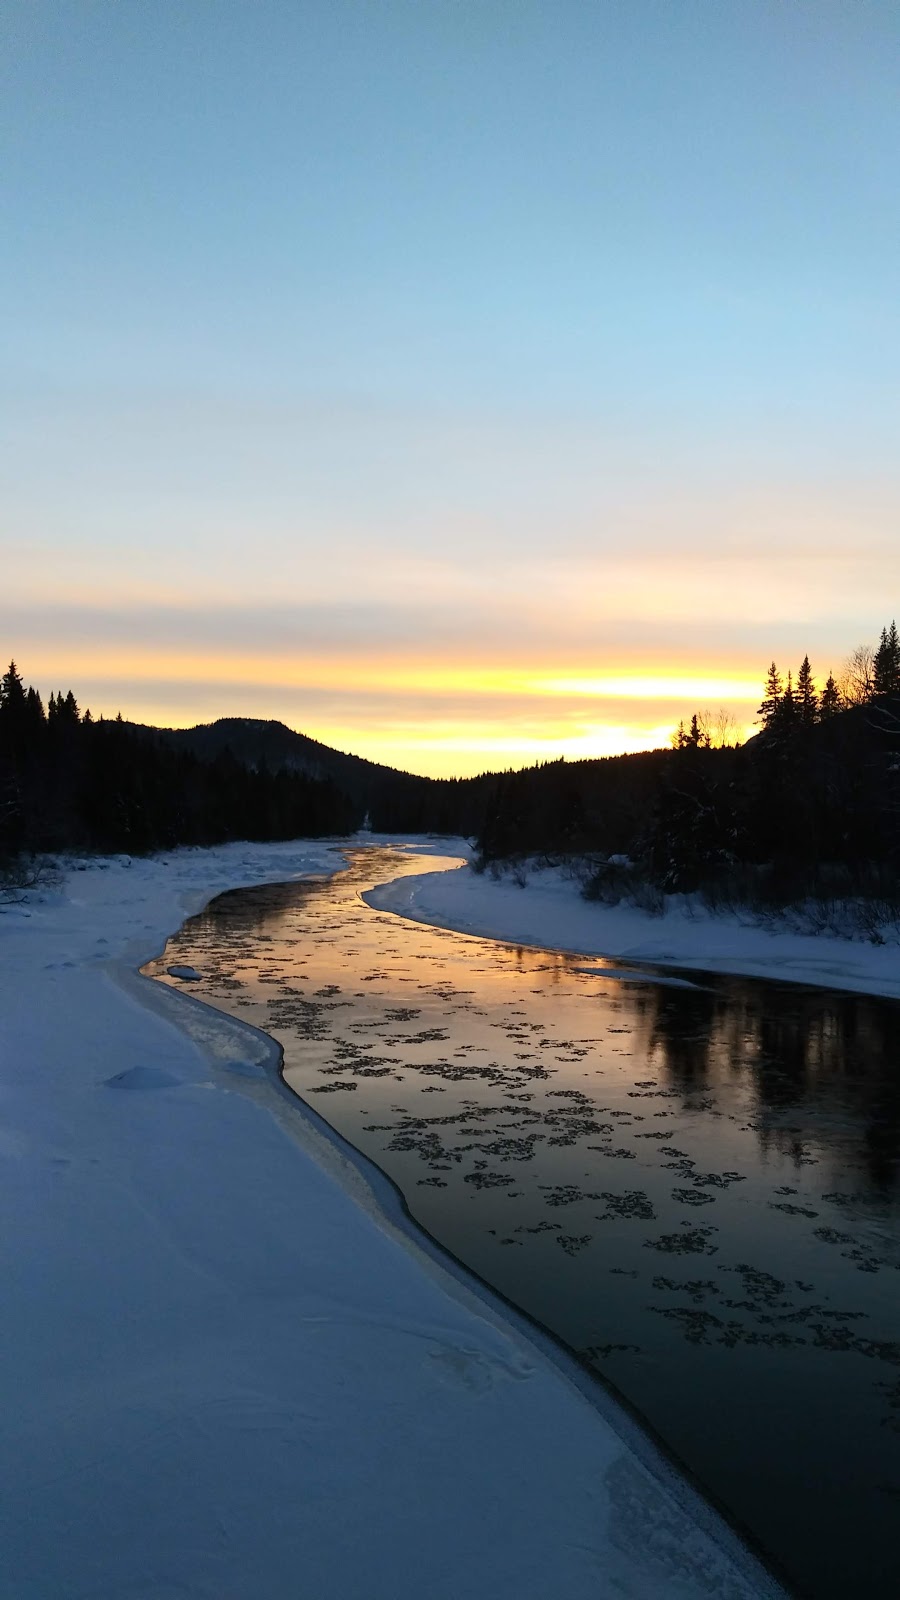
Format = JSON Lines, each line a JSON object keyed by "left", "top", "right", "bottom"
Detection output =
{"left": 0, "top": 624, "right": 900, "bottom": 928}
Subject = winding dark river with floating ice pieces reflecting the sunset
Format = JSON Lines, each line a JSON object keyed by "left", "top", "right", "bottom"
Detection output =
{"left": 146, "top": 848, "right": 900, "bottom": 1597}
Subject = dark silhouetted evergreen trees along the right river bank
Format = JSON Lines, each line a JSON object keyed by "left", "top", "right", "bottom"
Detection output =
{"left": 479, "top": 622, "right": 900, "bottom": 920}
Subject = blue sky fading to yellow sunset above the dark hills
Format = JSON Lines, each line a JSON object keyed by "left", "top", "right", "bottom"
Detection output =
{"left": 0, "top": 0, "right": 900, "bottom": 774}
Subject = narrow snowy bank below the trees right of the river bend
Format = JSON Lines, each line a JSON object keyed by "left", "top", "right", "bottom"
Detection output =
{"left": 365, "top": 851, "right": 900, "bottom": 998}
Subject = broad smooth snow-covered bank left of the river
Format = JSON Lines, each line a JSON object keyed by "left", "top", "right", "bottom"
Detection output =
{"left": 0, "top": 842, "right": 777, "bottom": 1600}
